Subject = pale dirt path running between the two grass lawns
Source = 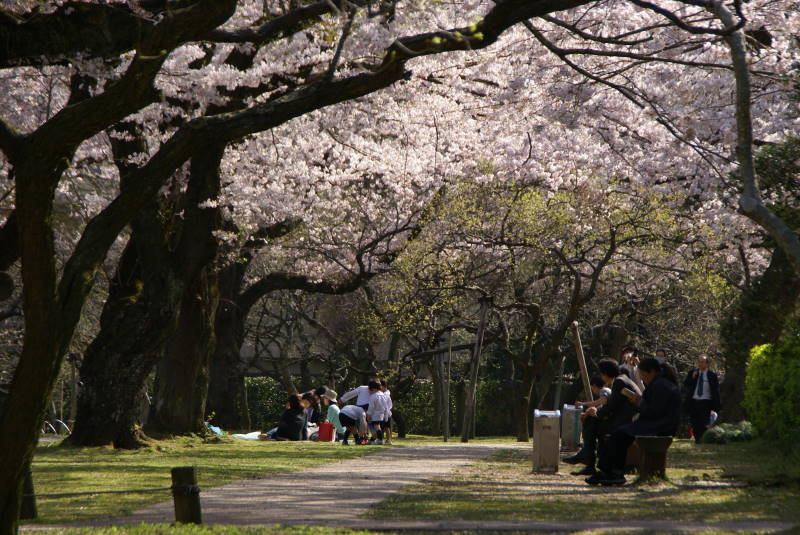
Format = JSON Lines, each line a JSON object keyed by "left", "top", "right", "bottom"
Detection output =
{"left": 114, "top": 444, "right": 524, "bottom": 526}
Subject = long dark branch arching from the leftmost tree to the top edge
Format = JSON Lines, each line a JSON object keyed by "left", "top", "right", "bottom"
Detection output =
{"left": 58, "top": 0, "right": 592, "bottom": 344}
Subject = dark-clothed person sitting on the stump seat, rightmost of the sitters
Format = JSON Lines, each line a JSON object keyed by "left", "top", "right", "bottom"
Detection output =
{"left": 586, "top": 358, "right": 681, "bottom": 485}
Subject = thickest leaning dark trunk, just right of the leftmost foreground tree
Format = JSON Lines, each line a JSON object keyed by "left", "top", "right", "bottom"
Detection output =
{"left": 70, "top": 146, "right": 224, "bottom": 448}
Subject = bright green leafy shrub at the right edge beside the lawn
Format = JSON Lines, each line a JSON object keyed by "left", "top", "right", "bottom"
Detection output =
{"left": 744, "top": 324, "right": 800, "bottom": 439}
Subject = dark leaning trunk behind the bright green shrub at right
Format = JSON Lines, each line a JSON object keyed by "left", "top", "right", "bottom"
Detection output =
{"left": 720, "top": 249, "right": 800, "bottom": 422}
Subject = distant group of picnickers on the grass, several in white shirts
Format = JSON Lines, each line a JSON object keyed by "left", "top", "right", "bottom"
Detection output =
{"left": 260, "top": 379, "right": 392, "bottom": 446}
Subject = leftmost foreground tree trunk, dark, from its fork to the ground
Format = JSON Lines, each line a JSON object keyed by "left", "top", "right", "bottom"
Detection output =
{"left": 0, "top": 154, "right": 69, "bottom": 535}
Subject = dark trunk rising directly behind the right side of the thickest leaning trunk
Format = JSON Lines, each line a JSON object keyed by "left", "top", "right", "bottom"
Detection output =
{"left": 146, "top": 266, "right": 219, "bottom": 434}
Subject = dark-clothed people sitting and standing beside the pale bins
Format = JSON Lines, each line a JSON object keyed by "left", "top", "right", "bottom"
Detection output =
{"left": 564, "top": 347, "right": 721, "bottom": 485}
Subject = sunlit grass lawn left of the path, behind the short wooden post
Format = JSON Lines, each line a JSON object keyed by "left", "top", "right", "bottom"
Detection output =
{"left": 27, "top": 438, "right": 380, "bottom": 533}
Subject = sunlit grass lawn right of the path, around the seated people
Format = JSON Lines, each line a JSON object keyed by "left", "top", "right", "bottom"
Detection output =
{"left": 370, "top": 441, "right": 800, "bottom": 522}
